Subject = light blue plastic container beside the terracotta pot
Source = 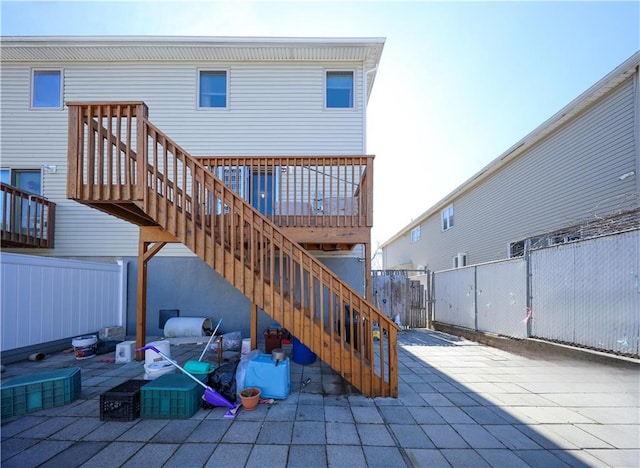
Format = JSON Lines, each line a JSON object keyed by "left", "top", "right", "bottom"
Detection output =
{"left": 244, "top": 354, "right": 291, "bottom": 400}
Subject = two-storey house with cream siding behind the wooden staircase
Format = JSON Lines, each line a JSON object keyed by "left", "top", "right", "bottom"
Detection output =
{"left": 0, "top": 37, "right": 384, "bottom": 340}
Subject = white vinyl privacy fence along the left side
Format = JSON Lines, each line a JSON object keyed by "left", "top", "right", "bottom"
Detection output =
{"left": 0, "top": 253, "right": 126, "bottom": 352}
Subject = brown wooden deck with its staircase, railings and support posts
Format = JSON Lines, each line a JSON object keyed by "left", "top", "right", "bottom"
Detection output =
{"left": 67, "top": 102, "right": 398, "bottom": 396}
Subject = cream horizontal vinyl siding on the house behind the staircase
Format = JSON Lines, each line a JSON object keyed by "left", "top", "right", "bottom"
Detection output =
{"left": 0, "top": 62, "right": 364, "bottom": 257}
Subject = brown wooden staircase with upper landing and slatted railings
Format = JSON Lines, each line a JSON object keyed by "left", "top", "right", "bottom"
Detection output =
{"left": 67, "top": 102, "right": 398, "bottom": 397}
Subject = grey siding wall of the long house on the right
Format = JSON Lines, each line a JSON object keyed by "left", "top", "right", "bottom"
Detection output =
{"left": 387, "top": 74, "right": 638, "bottom": 270}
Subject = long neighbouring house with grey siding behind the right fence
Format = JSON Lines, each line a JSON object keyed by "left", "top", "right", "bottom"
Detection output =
{"left": 381, "top": 52, "right": 640, "bottom": 271}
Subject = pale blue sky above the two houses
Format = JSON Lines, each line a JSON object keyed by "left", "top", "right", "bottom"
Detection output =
{"left": 0, "top": 0, "right": 640, "bottom": 254}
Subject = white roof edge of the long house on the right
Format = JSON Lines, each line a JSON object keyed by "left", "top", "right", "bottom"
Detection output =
{"left": 379, "top": 50, "right": 640, "bottom": 249}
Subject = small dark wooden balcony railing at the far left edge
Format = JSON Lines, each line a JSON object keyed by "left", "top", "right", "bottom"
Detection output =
{"left": 0, "top": 183, "right": 56, "bottom": 249}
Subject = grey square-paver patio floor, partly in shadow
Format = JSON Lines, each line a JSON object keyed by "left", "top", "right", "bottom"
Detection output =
{"left": 1, "top": 330, "right": 640, "bottom": 468}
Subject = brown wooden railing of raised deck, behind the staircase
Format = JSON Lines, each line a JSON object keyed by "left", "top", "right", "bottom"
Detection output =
{"left": 197, "top": 156, "right": 373, "bottom": 228}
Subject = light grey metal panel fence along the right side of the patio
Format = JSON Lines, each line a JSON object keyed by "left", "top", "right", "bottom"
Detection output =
{"left": 434, "top": 230, "right": 640, "bottom": 357}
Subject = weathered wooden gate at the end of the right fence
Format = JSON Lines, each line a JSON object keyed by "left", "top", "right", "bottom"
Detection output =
{"left": 372, "top": 270, "right": 431, "bottom": 328}
